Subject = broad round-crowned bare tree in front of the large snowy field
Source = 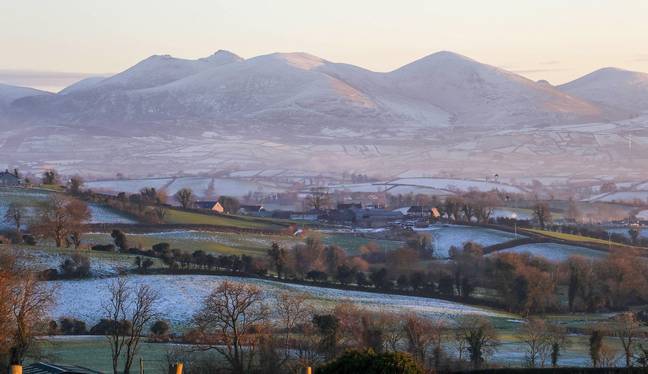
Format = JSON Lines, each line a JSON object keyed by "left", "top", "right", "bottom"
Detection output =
{"left": 194, "top": 281, "right": 269, "bottom": 374}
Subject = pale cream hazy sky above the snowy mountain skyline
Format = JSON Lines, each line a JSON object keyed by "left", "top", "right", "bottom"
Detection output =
{"left": 0, "top": 0, "right": 648, "bottom": 90}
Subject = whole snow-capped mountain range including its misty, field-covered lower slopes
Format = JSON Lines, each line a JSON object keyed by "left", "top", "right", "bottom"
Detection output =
{"left": 0, "top": 51, "right": 648, "bottom": 178}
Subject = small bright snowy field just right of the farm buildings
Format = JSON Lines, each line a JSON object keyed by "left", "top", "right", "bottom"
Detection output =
{"left": 414, "top": 225, "right": 523, "bottom": 258}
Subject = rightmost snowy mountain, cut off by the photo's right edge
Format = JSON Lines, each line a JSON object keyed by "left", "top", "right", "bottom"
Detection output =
{"left": 558, "top": 68, "right": 648, "bottom": 115}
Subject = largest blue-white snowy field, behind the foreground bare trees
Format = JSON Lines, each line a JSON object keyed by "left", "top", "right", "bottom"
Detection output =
{"left": 49, "top": 275, "right": 510, "bottom": 325}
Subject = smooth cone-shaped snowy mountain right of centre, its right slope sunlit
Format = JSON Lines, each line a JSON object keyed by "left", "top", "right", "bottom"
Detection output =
{"left": 390, "top": 52, "right": 601, "bottom": 126}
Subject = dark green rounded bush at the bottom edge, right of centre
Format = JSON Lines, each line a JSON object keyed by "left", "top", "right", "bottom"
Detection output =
{"left": 317, "top": 350, "right": 424, "bottom": 374}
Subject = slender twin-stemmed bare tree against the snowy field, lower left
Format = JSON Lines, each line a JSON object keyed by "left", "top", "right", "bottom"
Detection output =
{"left": 104, "top": 277, "right": 158, "bottom": 374}
